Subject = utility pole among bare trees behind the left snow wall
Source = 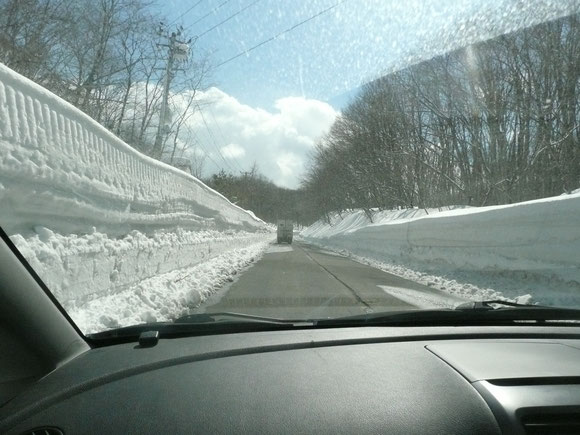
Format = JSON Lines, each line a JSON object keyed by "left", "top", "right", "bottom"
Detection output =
{"left": 151, "top": 23, "right": 191, "bottom": 159}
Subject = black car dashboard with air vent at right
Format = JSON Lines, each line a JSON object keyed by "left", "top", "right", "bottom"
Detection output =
{"left": 0, "top": 326, "right": 580, "bottom": 434}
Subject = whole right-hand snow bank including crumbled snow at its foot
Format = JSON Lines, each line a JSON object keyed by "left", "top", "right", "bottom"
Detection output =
{"left": 301, "top": 191, "right": 580, "bottom": 306}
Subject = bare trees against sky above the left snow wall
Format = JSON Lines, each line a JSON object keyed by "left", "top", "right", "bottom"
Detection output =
{"left": 0, "top": 0, "right": 208, "bottom": 167}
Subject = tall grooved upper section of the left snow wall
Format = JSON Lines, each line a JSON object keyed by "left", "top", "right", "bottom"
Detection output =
{"left": 0, "top": 64, "right": 264, "bottom": 235}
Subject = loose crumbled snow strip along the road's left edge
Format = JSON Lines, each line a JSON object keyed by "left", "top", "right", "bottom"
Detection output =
{"left": 64, "top": 241, "right": 270, "bottom": 333}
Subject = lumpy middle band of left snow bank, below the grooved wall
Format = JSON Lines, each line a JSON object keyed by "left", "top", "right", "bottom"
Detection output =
{"left": 11, "top": 227, "right": 273, "bottom": 303}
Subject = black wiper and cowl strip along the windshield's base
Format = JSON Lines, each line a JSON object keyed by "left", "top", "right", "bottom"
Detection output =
{"left": 87, "top": 300, "right": 580, "bottom": 345}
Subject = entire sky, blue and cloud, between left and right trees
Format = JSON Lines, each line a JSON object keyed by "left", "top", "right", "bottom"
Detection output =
{"left": 156, "top": 0, "right": 579, "bottom": 187}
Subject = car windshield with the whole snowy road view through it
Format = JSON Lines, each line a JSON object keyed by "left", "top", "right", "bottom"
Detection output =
{"left": 0, "top": 0, "right": 580, "bottom": 334}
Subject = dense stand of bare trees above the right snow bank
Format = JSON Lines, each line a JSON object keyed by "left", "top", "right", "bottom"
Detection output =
{"left": 303, "top": 15, "right": 580, "bottom": 221}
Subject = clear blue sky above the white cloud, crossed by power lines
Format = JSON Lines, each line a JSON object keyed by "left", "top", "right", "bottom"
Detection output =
{"left": 163, "top": 0, "right": 472, "bottom": 109}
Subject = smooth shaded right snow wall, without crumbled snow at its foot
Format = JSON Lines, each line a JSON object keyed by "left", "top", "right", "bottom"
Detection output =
{"left": 301, "top": 191, "right": 580, "bottom": 283}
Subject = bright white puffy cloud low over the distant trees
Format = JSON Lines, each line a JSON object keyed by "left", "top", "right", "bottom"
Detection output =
{"left": 174, "top": 88, "right": 337, "bottom": 188}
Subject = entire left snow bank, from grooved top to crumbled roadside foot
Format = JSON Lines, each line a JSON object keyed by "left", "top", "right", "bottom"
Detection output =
{"left": 0, "top": 64, "right": 273, "bottom": 332}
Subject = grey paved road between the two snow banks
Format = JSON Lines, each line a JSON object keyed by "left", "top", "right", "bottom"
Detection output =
{"left": 201, "top": 241, "right": 460, "bottom": 318}
